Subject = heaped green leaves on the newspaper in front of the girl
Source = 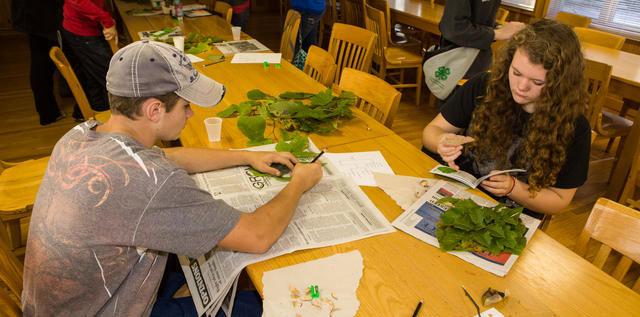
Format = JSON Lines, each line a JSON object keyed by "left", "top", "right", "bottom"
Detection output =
{"left": 436, "top": 197, "right": 527, "bottom": 255}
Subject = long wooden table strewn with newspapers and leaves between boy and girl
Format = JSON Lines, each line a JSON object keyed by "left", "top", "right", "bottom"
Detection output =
{"left": 117, "top": 2, "right": 640, "bottom": 316}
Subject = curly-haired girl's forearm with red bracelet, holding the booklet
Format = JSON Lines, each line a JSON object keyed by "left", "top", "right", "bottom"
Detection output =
{"left": 481, "top": 175, "right": 577, "bottom": 214}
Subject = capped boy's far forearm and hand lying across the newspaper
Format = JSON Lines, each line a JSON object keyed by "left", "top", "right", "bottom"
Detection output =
{"left": 163, "top": 147, "right": 298, "bottom": 175}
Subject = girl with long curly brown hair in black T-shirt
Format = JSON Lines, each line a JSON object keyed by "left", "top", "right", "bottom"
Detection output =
{"left": 422, "top": 20, "right": 591, "bottom": 214}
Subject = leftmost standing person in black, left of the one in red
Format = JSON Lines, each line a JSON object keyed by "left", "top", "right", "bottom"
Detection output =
{"left": 11, "top": 0, "right": 65, "bottom": 125}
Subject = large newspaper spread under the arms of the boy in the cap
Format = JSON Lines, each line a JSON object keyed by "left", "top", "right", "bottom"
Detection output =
{"left": 179, "top": 145, "right": 395, "bottom": 316}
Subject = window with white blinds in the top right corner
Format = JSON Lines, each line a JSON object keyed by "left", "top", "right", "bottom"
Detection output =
{"left": 547, "top": 0, "right": 640, "bottom": 40}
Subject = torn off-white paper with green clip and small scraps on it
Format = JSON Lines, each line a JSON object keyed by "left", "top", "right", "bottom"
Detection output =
{"left": 262, "top": 250, "right": 363, "bottom": 317}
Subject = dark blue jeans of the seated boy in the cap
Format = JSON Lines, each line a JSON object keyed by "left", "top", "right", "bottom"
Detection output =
{"left": 151, "top": 254, "right": 262, "bottom": 317}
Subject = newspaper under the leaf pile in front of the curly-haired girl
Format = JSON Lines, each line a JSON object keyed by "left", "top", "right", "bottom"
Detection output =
{"left": 392, "top": 180, "right": 540, "bottom": 276}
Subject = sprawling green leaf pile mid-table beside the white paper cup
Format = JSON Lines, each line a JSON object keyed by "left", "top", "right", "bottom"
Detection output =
{"left": 218, "top": 89, "right": 356, "bottom": 146}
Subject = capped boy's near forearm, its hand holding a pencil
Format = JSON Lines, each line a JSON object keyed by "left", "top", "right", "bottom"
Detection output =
{"left": 218, "top": 163, "right": 322, "bottom": 253}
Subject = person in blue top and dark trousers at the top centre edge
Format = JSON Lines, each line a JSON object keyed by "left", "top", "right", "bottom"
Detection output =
{"left": 291, "top": 0, "right": 325, "bottom": 52}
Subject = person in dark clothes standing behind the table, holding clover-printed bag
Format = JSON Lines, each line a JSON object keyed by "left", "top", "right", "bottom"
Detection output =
{"left": 440, "top": 0, "right": 525, "bottom": 78}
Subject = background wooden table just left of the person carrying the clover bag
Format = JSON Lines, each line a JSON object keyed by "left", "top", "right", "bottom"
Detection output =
{"left": 389, "top": 0, "right": 444, "bottom": 35}
